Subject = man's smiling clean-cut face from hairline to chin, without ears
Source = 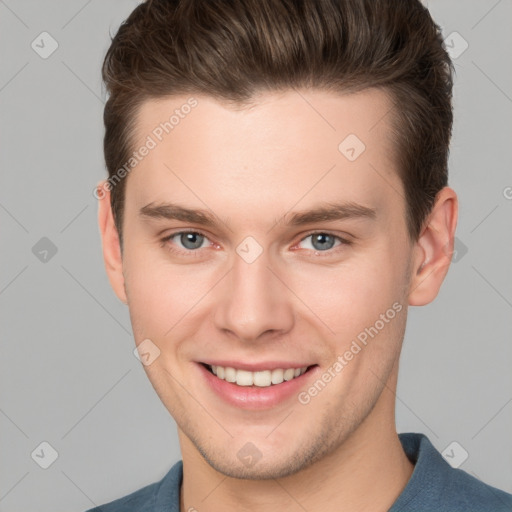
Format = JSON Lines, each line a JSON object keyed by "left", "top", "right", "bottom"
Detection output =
{"left": 117, "top": 90, "right": 412, "bottom": 478}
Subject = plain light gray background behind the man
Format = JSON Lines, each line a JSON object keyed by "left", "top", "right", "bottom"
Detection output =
{"left": 0, "top": 0, "right": 512, "bottom": 512}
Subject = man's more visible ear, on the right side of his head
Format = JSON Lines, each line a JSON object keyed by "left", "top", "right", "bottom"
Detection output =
{"left": 409, "top": 187, "right": 458, "bottom": 306}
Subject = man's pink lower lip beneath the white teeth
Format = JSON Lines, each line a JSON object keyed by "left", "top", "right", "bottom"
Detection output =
{"left": 197, "top": 363, "right": 319, "bottom": 409}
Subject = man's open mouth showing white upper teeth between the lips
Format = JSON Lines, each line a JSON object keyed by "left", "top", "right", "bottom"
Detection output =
{"left": 200, "top": 363, "right": 318, "bottom": 388}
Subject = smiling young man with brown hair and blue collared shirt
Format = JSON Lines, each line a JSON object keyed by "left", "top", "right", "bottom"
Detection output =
{"left": 88, "top": 0, "right": 512, "bottom": 512}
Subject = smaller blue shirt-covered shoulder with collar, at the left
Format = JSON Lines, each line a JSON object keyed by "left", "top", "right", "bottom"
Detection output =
{"left": 86, "top": 460, "right": 183, "bottom": 512}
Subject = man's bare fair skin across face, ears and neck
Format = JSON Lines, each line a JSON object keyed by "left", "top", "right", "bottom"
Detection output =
{"left": 98, "top": 90, "right": 458, "bottom": 512}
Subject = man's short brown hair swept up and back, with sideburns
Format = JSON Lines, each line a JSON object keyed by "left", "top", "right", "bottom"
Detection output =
{"left": 102, "top": 0, "right": 453, "bottom": 243}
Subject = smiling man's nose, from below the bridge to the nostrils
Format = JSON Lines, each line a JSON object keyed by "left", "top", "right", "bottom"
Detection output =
{"left": 215, "top": 245, "right": 294, "bottom": 342}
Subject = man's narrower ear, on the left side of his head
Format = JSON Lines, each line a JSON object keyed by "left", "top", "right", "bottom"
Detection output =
{"left": 95, "top": 180, "right": 128, "bottom": 304}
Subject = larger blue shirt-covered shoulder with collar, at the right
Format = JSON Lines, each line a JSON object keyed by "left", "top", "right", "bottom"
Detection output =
{"left": 390, "top": 434, "right": 512, "bottom": 512}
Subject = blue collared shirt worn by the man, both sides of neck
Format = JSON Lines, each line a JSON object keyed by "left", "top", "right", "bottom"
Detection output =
{"left": 86, "top": 433, "right": 512, "bottom": 512}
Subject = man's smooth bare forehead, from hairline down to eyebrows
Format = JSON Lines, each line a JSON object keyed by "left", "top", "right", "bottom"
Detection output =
{"left": 127, "top": 89, "right": 404, "bottom": 226}
